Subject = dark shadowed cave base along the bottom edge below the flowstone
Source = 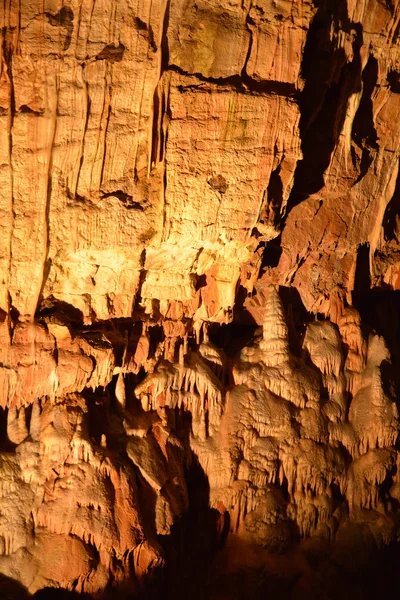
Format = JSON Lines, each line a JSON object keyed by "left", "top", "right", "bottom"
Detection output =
{"left": 0, "top": 540, "right": 400, "bottom": 600}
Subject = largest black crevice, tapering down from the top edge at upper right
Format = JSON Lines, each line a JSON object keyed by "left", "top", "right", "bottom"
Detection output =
{"left": 288, "top": 0, "right": 363, "bottom": 212}
